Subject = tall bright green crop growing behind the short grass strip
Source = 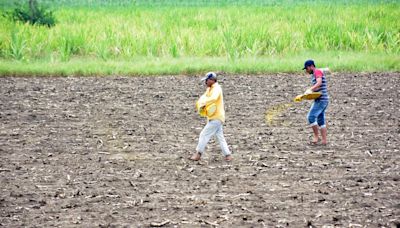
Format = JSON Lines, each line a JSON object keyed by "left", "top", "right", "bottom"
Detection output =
{"left": 0, "top": 0, "right": 400, "bottom": 75}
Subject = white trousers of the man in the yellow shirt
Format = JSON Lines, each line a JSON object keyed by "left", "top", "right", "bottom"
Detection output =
{"left": 196, "top": 120, "right": 231, "bottom": 156}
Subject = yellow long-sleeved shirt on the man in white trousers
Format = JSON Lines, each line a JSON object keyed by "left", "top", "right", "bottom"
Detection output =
{"left": 202, "top": 82, "right": 225, "bottom": 123}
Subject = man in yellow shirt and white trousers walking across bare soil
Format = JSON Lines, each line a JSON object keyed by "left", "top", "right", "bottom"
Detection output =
{"left": 190, "top": 72, "right": 232, "bottom": 161}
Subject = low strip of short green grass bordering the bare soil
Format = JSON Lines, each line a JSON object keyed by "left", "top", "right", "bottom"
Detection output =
{"left": 0, "top": 52, "right": 400, "bottom": 76}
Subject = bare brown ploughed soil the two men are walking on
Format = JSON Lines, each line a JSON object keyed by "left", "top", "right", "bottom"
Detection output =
{"left": 0, "top": 73, "right": 400, "bottom": 227}
